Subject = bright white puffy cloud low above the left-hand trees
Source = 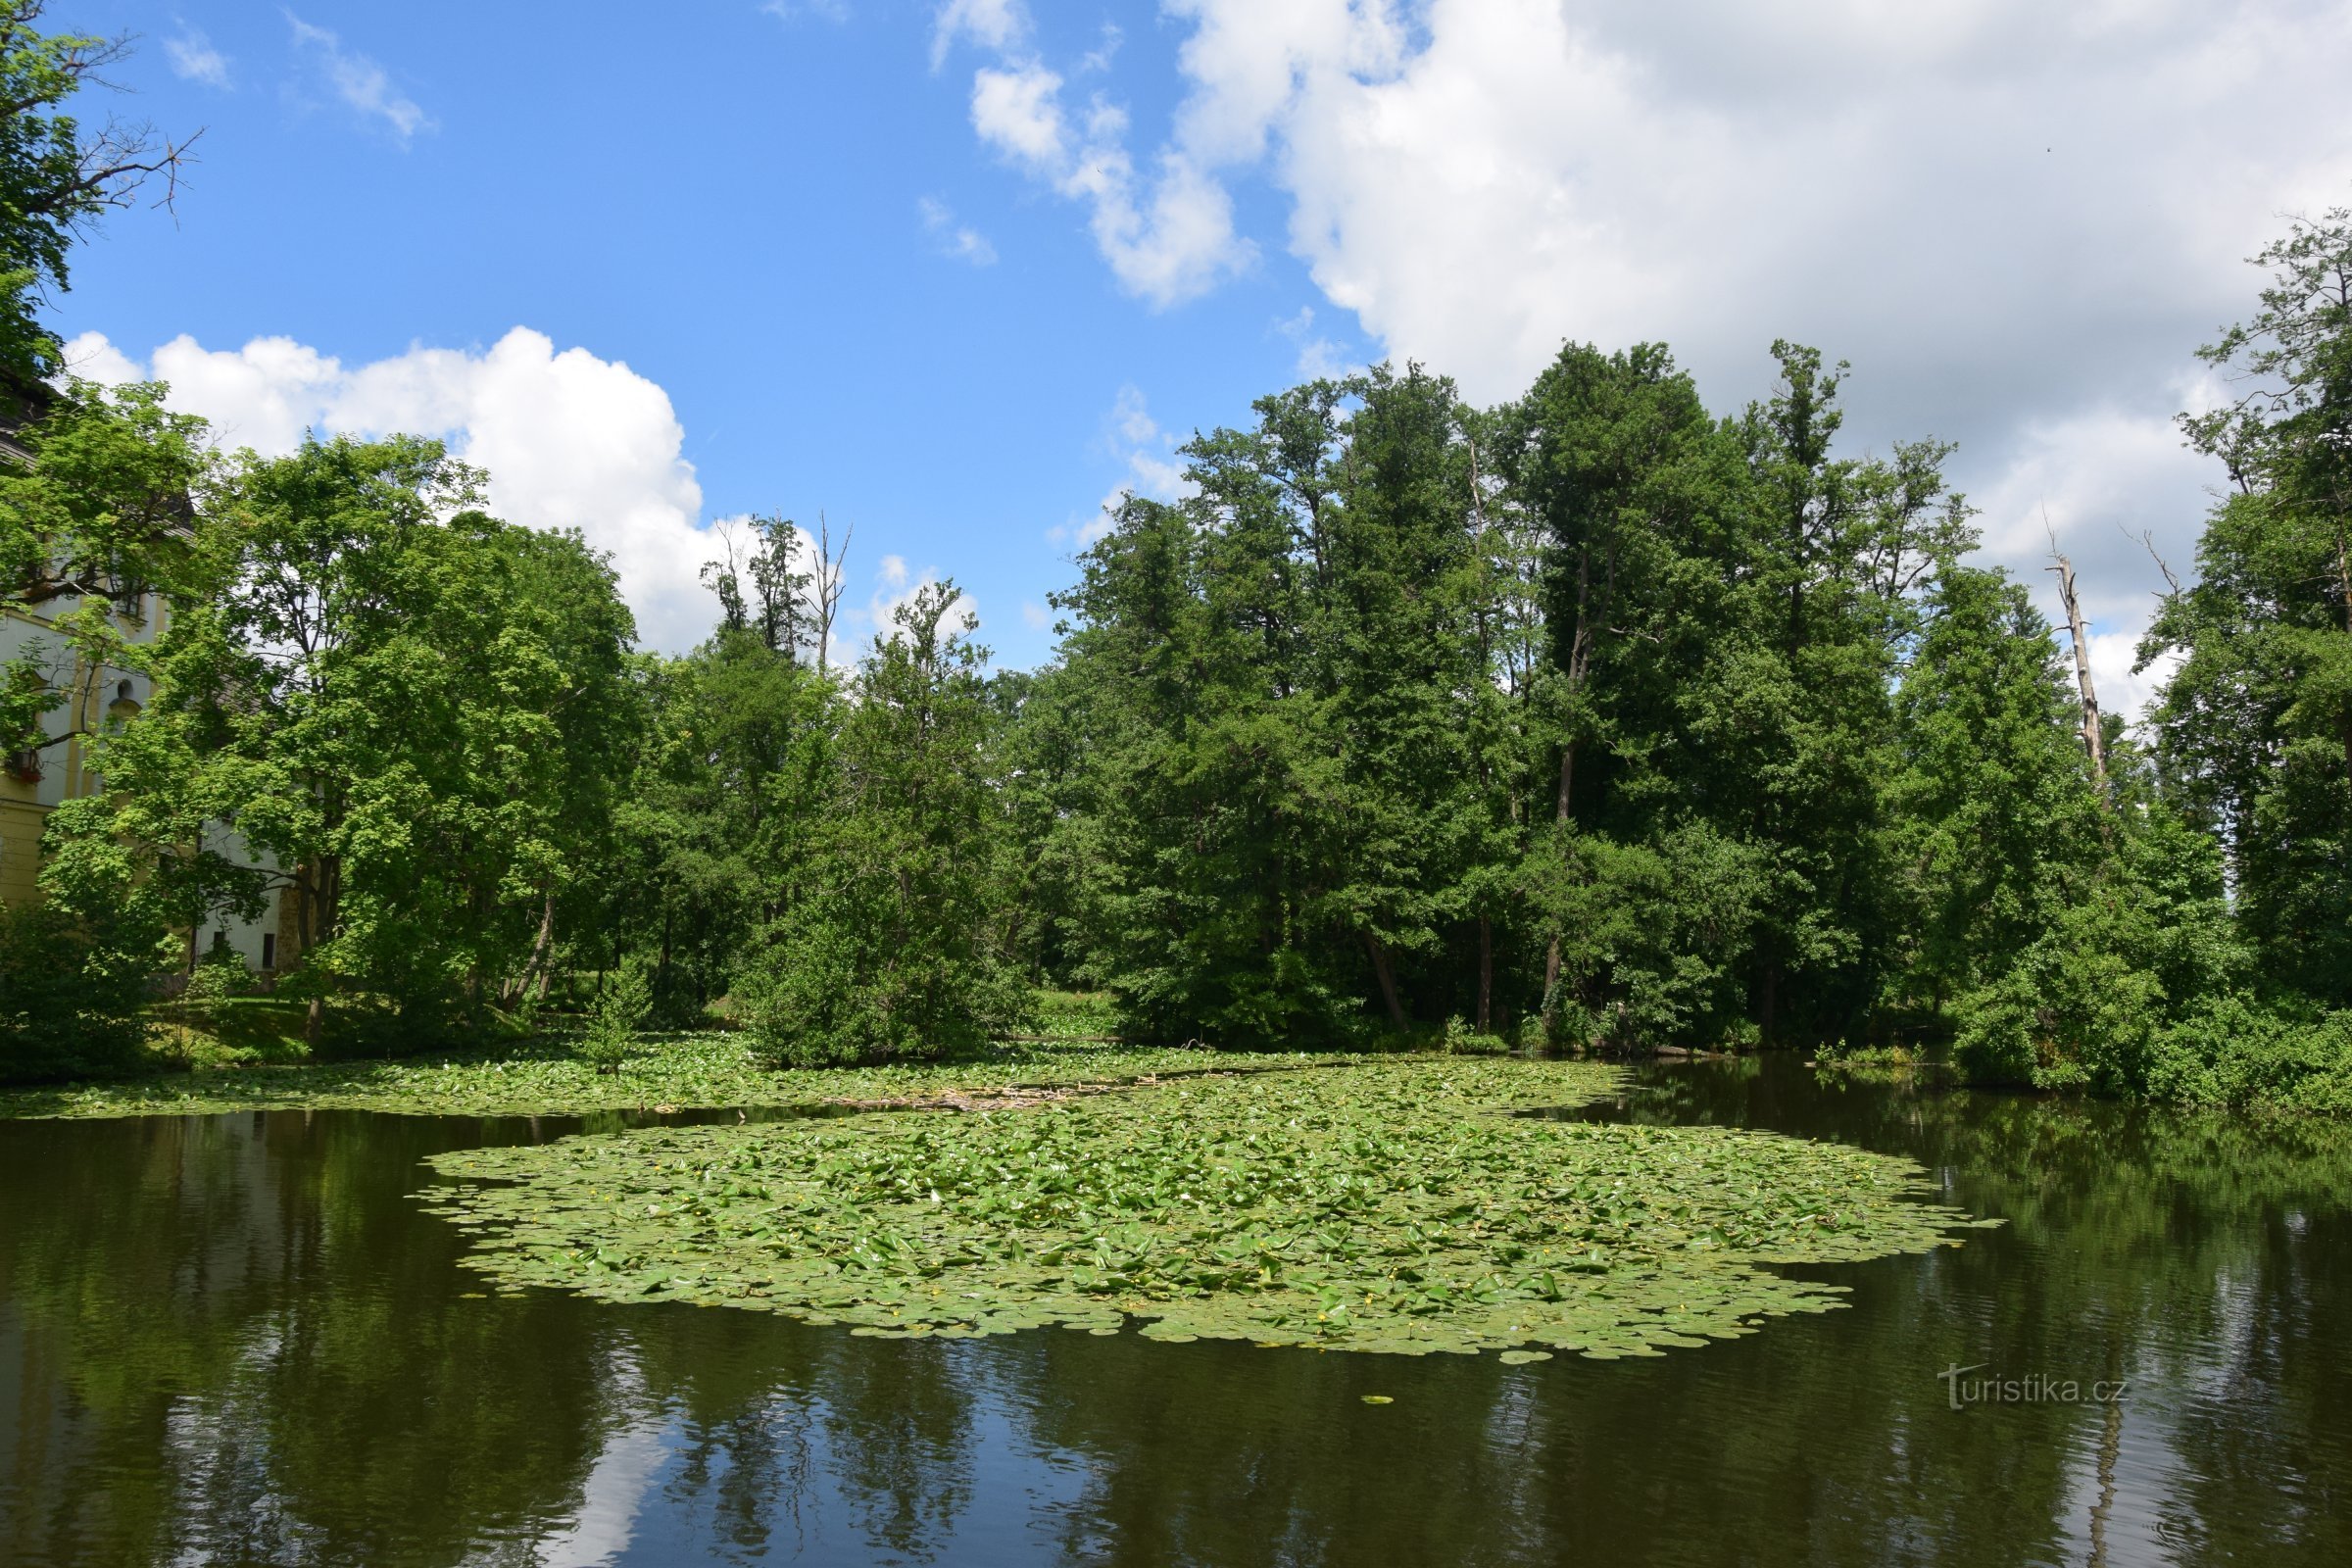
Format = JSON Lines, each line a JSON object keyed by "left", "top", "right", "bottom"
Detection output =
{"left": 66, "top": 326, "right": 715, "bottom": 651}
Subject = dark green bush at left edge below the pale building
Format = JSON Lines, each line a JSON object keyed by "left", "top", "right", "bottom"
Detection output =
{"left": 0, "top": 906, "right": 146, "bottom": 1084}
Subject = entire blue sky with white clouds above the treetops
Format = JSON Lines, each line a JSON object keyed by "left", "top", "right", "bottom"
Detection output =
{"left": 49, "top": 0, "right": 2352, "bottom": 686}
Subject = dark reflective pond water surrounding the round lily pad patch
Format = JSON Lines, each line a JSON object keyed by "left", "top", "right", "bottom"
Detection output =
{"left": 0, "top": 1057, "right": 2352, "bottom": 1568}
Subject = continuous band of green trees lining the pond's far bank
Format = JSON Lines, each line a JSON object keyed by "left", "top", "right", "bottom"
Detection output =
{"left": 0, "top": 0, "right": 2352, "bottom": 1107}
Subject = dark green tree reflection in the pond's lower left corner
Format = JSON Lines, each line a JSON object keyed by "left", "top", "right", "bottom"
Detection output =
{"left": 0, "top": 1112, "right": 605, "bottom": 1563}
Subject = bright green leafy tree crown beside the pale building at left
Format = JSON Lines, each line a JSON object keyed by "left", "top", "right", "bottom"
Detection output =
{"left": 45, "top": 440, "right": 633, "bottom": 1044}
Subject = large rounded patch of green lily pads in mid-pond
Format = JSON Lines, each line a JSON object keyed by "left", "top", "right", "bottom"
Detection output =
{"left": 423, "top": 1057, "right": 1981, "bottom": 1361}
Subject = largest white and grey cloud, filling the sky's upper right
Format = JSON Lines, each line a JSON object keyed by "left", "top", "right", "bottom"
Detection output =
{"left": 945, "top": 0, "right": 2352, "bottom": 723}
